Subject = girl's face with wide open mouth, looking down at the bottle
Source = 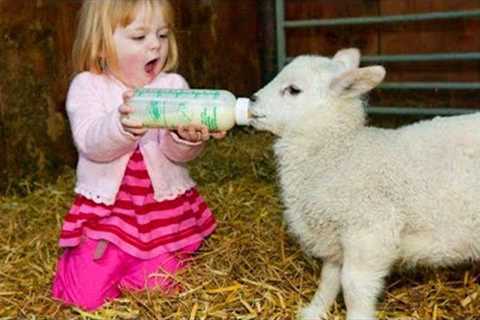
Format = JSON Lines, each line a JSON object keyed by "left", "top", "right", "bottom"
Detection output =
{"left": 113, "top": 6, "right": 169, "bottom": 88}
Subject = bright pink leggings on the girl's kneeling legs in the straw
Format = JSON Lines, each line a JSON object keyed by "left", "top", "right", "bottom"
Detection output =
{"left": 52, "top": 239, "right": 198, "bottom": 310}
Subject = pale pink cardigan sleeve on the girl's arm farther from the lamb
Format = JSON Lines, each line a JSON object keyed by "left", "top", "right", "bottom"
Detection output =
{"left": 67, "top": 73, "right": 139, "bottom": 162}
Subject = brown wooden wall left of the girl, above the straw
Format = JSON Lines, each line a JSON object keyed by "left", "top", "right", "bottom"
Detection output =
{"left": 0, "top": 0, "right": 78, "bottom": 190}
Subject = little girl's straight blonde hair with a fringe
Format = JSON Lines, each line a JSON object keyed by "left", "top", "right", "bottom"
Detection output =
{"left": 72, "top": 0, "right": 178, "bottom": 73}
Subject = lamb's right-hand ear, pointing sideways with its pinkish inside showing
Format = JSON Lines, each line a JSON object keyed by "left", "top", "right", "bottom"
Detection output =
{"left": 330, "top": 66, "right": 385, "bottom": 98}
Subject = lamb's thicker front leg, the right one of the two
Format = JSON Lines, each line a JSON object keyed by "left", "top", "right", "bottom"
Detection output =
{"left": 341, "top": 234, "right": 395, "bottom": 320}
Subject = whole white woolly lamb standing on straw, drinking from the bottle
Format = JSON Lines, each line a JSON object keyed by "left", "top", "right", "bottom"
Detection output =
{"left": 252, "top": 49, "right": 480, "bottom": 320}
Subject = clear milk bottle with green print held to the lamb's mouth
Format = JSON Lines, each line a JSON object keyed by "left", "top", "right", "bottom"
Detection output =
{"left": 128, "top": 88, "right": 250, "bottom": 131}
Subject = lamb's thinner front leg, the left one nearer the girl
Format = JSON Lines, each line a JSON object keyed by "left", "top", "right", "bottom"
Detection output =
{"left": 298, "top": 260, "right": 341, "bottom": 320}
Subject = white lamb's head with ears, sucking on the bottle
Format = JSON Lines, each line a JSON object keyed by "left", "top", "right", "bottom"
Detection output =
{"left": 251, "top": 49, "right": 385, "bottom": 136}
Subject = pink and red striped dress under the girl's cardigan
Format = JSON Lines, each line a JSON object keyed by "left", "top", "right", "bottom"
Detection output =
{"left": 59, "top": 148, "right": 216, "bottom": 259}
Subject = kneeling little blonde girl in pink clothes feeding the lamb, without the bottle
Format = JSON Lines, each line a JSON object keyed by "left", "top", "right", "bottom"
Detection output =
{"left": 53, "top": 0, "right": 225, "bottom": 310}
